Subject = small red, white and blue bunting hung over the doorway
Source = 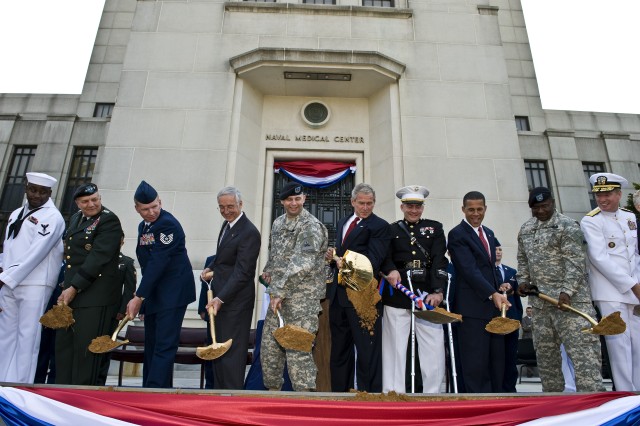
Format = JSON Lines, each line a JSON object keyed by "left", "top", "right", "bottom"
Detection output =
{"left": 273, "top": 160, "right": 356, "bottom": 188}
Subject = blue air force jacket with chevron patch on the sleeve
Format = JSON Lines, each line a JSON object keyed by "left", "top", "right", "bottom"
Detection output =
{"left": 136, "top": 210, "right": 196, "bottom": 314}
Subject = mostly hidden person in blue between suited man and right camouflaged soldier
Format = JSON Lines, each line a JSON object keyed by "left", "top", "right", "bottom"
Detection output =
{"left": 496, "top": 238, "right": 522, "bottom": 392}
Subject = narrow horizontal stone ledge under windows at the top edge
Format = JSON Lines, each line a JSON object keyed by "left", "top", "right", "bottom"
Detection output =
{"left": 224, "top": 1, "right": 413, "bottom": 19}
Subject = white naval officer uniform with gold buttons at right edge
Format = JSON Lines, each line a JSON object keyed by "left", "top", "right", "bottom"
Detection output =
{"left": 580, "top": 209, "right": 640, "bottom": 391}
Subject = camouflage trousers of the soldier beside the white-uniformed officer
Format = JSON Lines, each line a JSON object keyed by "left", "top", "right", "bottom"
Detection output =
{"left": 533, "top": 303, "right": 605, "bottom": 392}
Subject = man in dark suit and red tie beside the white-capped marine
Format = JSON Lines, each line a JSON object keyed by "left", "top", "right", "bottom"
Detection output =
{"left": 325, "top": 183, "right": 390, "bottom": 392}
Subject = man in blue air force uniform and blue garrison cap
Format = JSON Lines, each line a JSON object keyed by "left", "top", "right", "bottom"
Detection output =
{"left": 127, "top": 181, "right": 196, "bottom": 388}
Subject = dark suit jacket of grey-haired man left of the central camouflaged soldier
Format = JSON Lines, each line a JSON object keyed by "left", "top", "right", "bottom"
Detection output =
{"left": 207, "top": 213, "right": 260, "bottom": 310}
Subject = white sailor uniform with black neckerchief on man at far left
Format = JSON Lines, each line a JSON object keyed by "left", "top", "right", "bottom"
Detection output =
{"left": 0, "top": 199, "right": 65, "bottom": 383}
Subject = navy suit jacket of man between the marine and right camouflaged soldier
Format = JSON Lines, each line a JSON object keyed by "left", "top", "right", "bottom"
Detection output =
{"left": 447, "top": 220, "right": 501, "bottom": 320}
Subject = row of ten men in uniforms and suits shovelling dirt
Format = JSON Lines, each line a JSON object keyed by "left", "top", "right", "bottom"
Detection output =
{"left": 0, "top": 169, "right": 640, "bottom": 393}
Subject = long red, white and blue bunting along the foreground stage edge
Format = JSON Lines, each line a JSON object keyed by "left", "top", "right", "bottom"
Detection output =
{"left": 0, "top": 386, "right": 640, "bottom": 426}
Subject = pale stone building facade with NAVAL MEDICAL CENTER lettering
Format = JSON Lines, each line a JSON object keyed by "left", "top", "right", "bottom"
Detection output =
{"left": 0, "top": 0, "right": 640, "bottom": 320}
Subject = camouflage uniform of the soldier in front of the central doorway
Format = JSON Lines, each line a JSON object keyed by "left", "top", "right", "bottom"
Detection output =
{"left": 260, "top": 209, "right": 328, "bottom": 391}
